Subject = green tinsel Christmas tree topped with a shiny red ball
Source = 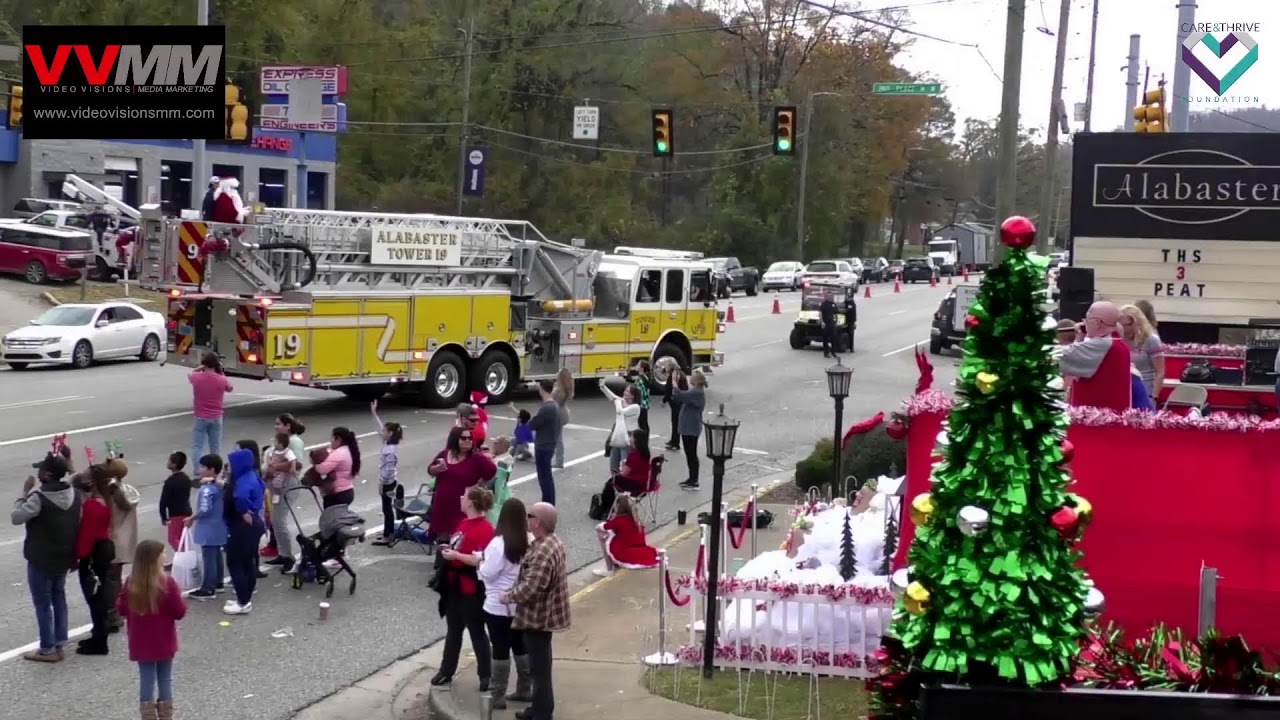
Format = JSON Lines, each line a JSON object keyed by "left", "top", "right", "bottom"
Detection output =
{"left": 869, "top": 218, "right": 1092, "bottom": 719}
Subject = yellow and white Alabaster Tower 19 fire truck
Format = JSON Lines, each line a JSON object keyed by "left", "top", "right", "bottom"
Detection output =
{"left": 138, "top": 208, "right": 723, "bottom": 406}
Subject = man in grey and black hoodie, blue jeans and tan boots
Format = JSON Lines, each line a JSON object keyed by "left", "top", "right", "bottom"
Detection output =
{"left": 10, "top": 454, "right": 81, "bottom": 662}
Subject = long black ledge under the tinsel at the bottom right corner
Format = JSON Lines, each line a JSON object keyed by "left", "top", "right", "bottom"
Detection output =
{"left": 919, "top": 685, "right": 1280, "bottom": 720}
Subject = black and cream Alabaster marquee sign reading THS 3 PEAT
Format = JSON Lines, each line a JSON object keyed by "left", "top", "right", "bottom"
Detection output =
{"left": 1071, "top": 133, "right": 1280, "bottom": 325}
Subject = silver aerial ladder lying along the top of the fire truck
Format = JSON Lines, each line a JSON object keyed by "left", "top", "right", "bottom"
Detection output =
{"left": 193, "top": 209, "right": 600, "bottom": 300}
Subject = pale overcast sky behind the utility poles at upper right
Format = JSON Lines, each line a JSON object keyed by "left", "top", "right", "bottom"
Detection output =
{"left": 885, "top": 0, "right": 1280, "bottom": 132}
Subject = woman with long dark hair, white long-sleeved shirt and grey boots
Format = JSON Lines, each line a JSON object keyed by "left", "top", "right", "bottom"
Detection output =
{"left": 476, "top": 497, "right": 532, "bottom": 710}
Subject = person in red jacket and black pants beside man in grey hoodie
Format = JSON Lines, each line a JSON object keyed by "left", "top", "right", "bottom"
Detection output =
{"left": 76, "top": 465, "right": 116, "bottom": 655}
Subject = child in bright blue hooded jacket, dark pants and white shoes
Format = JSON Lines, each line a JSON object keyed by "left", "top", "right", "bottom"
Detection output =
{"left": 223, "top": 442, "right": 266, "bottom": 615}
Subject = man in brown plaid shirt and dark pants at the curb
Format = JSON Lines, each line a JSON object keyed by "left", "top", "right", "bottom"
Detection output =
{"left": 500, "top": 502, "right": 570, "bottom": 720}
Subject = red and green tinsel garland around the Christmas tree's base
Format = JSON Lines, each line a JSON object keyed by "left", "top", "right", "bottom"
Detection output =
{"left": 867, "top": 624, "right": 1280, "bottom": 720}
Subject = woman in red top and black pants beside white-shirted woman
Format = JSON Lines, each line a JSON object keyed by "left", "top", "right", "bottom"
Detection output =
{"left": 431, "top": 486, "right": 493, "bottom": 693}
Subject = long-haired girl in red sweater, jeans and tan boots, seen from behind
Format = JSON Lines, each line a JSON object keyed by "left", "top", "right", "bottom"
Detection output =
{"left": 115, "top": 541, "right": 187, "bottom": 720}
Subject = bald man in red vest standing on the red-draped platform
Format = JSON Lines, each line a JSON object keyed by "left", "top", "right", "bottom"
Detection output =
{"left": 1057, "top": 301, "right": 1133, "bottom": 413}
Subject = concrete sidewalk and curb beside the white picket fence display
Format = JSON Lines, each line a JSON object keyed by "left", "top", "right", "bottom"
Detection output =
{"left": 293, "top": 473, "right": 791, "bottom": 720}
